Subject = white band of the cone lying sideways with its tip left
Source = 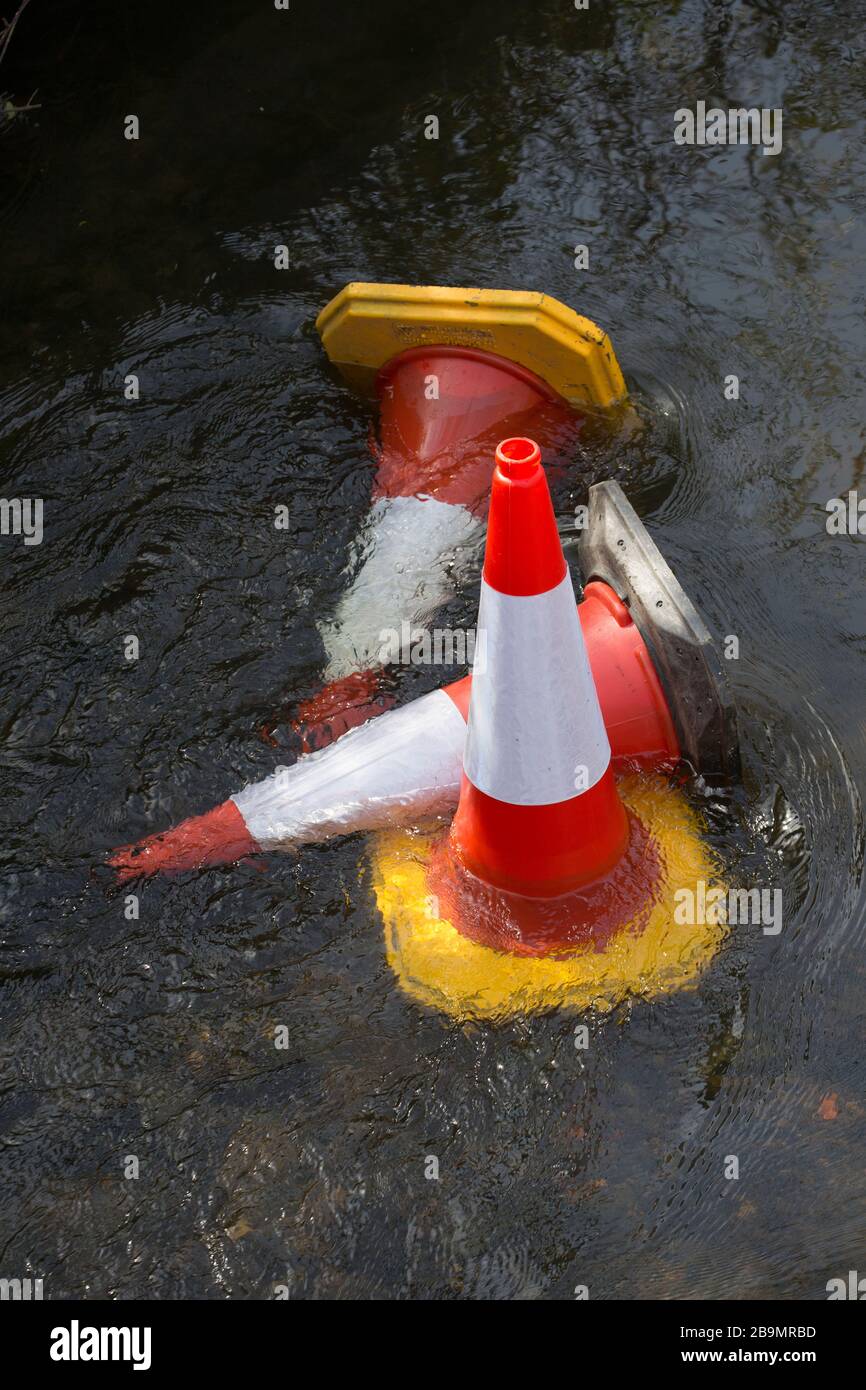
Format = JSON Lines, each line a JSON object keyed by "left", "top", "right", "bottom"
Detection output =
{"left": 232, "top": 691, "right": 466, "bottom": 849}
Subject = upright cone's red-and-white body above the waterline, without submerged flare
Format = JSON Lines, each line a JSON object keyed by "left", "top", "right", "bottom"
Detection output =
{"left": 450, "top": 438, "right": 630, "bottom": 898}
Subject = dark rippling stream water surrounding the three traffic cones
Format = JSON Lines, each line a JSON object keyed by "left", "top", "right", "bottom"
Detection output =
{"left": 0, "top": 0, "right": 866, "bottom": 1298}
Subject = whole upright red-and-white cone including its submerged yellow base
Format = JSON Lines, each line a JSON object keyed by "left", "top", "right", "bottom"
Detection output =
{"left": 374, "top": 439, "right": 733, "bottom": 1016}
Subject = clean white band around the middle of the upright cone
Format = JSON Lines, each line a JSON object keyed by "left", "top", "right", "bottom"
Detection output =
{"left": 466, "top": 574, "right": 610, "bottom": 806}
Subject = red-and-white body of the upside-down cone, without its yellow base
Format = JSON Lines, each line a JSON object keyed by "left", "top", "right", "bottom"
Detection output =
{"left": 295, "top": 346, "right": 581, "bottom": 751}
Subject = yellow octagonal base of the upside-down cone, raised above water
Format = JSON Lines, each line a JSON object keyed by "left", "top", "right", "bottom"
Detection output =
{"left": 316, "top": 282, "right": 626, "bottom": 410}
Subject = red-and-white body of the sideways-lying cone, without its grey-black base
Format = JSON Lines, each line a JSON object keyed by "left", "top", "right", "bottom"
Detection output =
{"left": 110, "top": 584, "right": 680, "bottom": 880}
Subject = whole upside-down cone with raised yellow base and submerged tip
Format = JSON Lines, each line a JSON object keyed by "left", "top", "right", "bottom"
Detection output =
{"left": 291, "top": 284, "right": 626, "bottom": 752}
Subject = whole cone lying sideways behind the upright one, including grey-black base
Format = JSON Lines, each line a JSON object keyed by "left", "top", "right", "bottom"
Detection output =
{"left": 111, "top": 482, "right": 738, "bottom": 877}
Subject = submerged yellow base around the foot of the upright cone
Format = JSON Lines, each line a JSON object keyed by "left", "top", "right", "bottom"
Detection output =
{"left": 373, "top": 777, "right": 726, "bottom": 1019}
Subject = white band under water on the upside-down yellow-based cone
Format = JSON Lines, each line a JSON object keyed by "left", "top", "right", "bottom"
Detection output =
{"left": 320, "top": 496, "right": 484, "bottom": 681}
